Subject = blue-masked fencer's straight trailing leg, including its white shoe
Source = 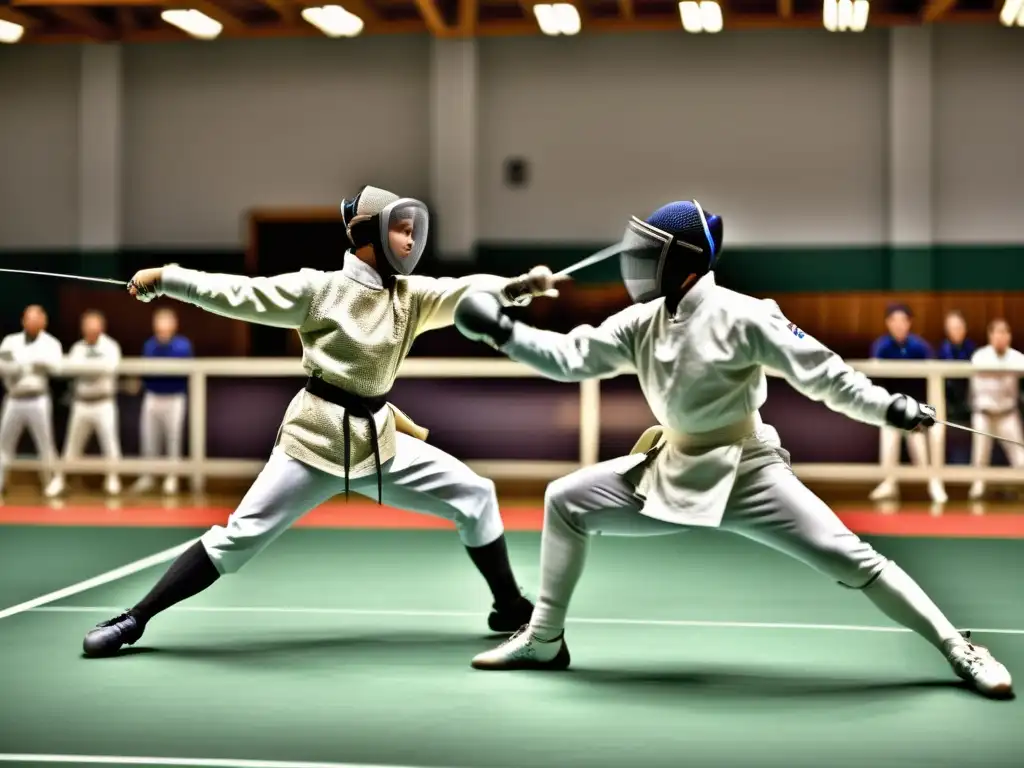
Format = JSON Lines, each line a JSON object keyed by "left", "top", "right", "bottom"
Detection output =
{"left": 722, "top": 463, "right": 1011, "bottom": 695}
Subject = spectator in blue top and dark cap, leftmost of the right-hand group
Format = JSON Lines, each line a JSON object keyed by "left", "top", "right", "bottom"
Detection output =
{"left": 870, "top": 304, "right": 949, "bottom": 504}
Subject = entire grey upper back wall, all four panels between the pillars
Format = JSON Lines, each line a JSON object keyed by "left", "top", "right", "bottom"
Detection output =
{"left": 0, "top": 25, "right": 1024, "bottom": 248}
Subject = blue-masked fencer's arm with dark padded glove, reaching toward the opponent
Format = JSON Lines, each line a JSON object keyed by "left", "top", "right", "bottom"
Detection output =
{"left": 456, "top": 294, "right": 650, "bottom": 382}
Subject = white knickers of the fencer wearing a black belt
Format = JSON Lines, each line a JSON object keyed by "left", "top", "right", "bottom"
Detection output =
{"left": 202, "top": 432, "right": 505, "bottom": 573}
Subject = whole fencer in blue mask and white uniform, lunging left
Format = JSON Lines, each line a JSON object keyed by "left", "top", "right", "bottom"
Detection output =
{"left": 455, "top": 201, "right": 1012, "bottom": 697}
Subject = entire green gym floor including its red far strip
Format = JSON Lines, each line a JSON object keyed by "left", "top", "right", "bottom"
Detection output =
{"left": 0, "top": 492, "right": 1024, "bottom": 768}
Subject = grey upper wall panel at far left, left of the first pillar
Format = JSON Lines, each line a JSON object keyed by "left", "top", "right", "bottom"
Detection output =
{"left": 0, "top": 45, "right": 80, "bottom": 248}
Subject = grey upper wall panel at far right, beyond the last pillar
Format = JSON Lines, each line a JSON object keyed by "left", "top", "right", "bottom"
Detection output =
{"left": 933, "top": 24, "right": 1024, "bottom": 243}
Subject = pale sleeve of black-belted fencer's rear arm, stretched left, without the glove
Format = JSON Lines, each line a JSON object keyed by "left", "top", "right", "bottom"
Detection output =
{"left": 151, "top": 264, "right": 327, "bottom": 329}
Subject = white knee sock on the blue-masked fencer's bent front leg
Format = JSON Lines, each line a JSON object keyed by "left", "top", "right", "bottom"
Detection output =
{"left": 529, "top": 500, "right": 590, "bottom": 640}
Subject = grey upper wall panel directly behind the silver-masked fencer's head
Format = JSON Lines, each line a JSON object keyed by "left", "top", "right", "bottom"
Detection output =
{"left": 124, "top": 37, "right": 429, "bottom": 246}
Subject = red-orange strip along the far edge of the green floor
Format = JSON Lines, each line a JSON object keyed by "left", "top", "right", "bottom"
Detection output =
{"left": 0, "top": 503, "right": 1024, "bottom": 539}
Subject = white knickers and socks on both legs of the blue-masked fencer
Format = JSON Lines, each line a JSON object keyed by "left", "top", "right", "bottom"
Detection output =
{"left": 530, "top": 448, "right": 958, "bottom": 648}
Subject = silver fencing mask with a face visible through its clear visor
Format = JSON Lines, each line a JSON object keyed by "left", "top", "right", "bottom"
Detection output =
{"left": 341, "top": 186, "right": 430, "bottom": 275}
